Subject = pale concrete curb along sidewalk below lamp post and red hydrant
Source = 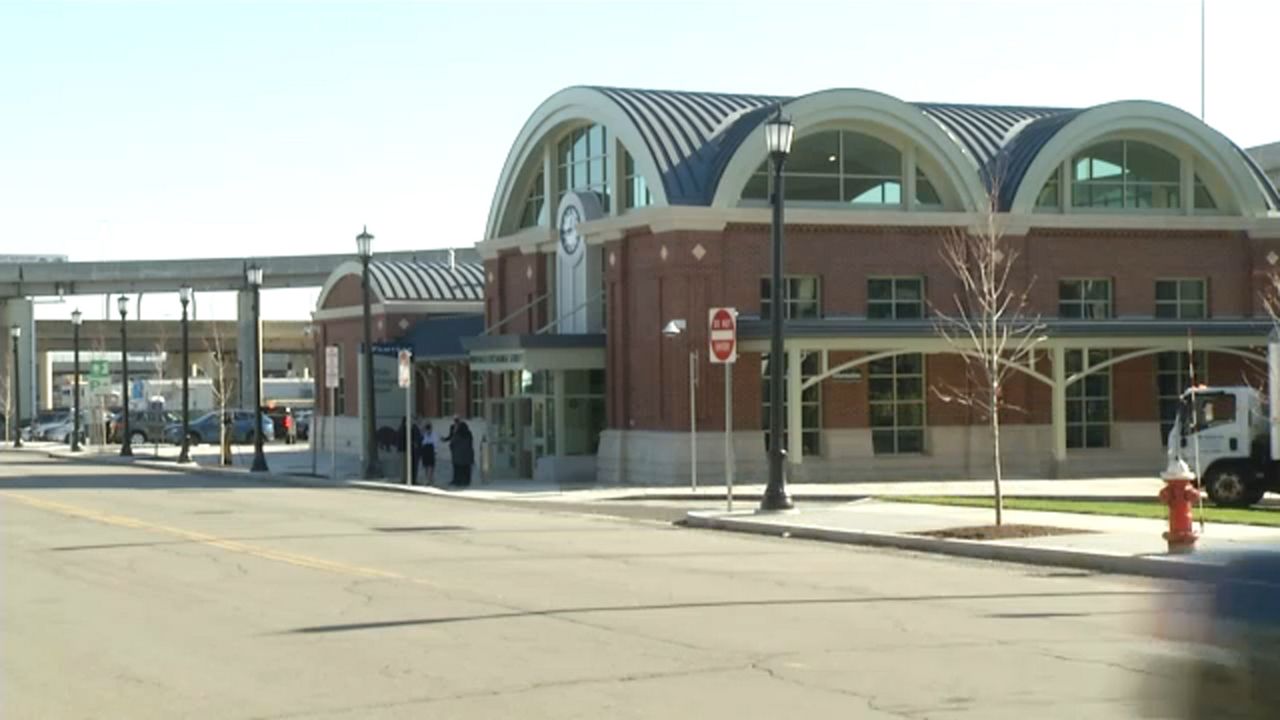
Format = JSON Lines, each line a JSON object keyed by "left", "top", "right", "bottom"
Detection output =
{"left": 677, "top": 511, "right": 1221, "bottom": 580}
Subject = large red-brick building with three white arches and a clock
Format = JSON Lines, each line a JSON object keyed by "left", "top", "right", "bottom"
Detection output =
{"left": 465, "top": 87, "right": 1280, "bottom": 483}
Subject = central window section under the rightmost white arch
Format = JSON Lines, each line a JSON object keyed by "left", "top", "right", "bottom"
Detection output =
{"left": 1071, "top": 140, "right": 1181, "bottom": 210}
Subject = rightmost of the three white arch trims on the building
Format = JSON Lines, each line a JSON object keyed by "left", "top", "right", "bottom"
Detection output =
{"left": 1010, "top": 100, "right": 1267, "bottom": 217}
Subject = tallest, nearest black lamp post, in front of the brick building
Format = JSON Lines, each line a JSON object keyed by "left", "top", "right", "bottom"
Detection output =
{"left": 760, "top": 105, "right": 800, "bottom": 510}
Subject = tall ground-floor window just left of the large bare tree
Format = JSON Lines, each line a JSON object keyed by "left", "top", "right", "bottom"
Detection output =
{"left": 867, "top": 352, "right": 924, "bottom": 455}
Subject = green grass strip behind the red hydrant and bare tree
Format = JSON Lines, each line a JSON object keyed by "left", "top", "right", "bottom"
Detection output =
{"left": 878, "top": 495, "right": 1280, "bottom": 528}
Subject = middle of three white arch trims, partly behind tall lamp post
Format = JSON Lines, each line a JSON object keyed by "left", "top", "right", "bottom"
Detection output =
{"left": 712, "top": 90, "right": 987, "bottom": 211}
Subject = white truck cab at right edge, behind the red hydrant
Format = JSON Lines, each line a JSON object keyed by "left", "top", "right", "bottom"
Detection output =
{"left": 1167, "top": 386, "right": 1276, "bottom": 507}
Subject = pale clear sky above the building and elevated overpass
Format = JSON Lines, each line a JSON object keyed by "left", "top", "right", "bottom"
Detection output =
{"left": 0, "top": 0, "right": 1280, "bottom": 316}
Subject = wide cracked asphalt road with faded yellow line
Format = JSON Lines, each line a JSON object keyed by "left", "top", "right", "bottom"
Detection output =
{"left": 0, "top": 452, "right": 1183, "bottom": 720}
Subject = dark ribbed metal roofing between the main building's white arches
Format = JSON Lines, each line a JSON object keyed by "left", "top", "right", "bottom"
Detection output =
{"left": 590, "top": 87, "right": 1280, "bottom": 210}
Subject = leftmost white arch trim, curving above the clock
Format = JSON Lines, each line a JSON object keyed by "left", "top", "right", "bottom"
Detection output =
{"left": 485, "top": 87, "right": 667, "bottom": 240}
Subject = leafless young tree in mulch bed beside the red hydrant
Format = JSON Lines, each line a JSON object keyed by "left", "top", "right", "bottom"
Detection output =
{"left": 933, "top": 184, "right": 1046, "bottom": 525}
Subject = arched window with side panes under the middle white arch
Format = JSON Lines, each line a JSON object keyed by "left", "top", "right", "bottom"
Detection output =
{"left": 742, "top": 131, "right": 906, "bottom": 208}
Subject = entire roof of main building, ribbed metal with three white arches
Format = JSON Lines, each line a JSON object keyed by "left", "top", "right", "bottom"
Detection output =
{"left": 486, "top": 86, "right": 1280, "bottom": 237}
